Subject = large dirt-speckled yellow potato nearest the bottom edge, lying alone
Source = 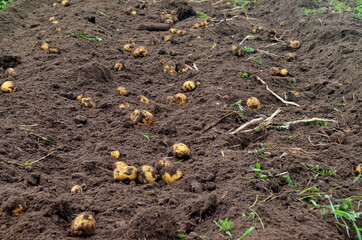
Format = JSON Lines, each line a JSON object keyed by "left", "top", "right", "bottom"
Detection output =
{"left": 71, "top": 213, "right": 96, "bottom": 237}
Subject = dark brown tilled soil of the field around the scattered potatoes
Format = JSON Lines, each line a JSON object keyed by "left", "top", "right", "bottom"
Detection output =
{"left": 0, "top": 0, "right": 362, "bottom": 240}
